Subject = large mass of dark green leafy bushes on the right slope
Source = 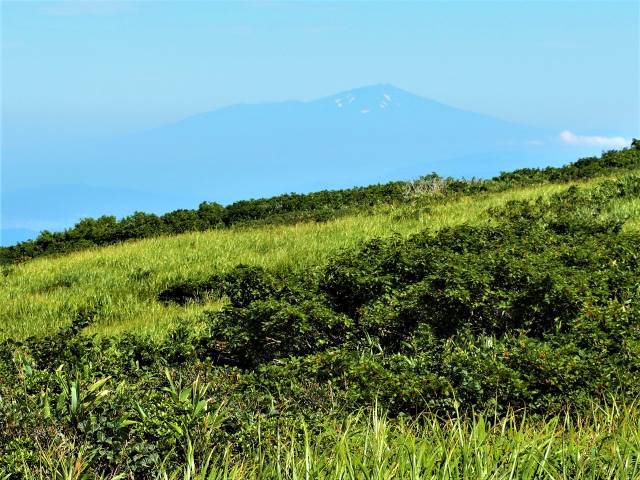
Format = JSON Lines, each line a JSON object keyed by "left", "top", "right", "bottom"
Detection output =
{"left": 198, "top": 177, "right": 640, "bottom": 412}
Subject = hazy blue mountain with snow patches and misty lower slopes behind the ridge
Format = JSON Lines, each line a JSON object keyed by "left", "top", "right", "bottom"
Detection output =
{"left": 2, "top": 84, "right": 632, "bottom": 244}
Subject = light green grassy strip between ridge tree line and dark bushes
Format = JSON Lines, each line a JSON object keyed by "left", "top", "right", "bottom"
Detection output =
{"left": 0, "top": 178, "right": 640, "bottom": 339}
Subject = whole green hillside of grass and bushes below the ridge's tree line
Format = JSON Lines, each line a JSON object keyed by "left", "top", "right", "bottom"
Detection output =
{"left": 0, "top": 150, "right": 640, "bottom": 479}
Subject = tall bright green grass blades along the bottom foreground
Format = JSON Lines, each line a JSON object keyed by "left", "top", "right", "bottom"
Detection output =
{"left": 23, "top": 402, "right": 640, "bottom": 480}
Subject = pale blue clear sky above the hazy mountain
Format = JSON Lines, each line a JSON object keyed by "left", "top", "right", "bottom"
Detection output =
{"left": 2, "top": 1, "right": 640, "bottom": 148}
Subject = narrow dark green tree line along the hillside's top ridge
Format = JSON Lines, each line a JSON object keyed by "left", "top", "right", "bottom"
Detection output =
{"left": 0, "top": 144, "right": 640, "bottom": 264}
